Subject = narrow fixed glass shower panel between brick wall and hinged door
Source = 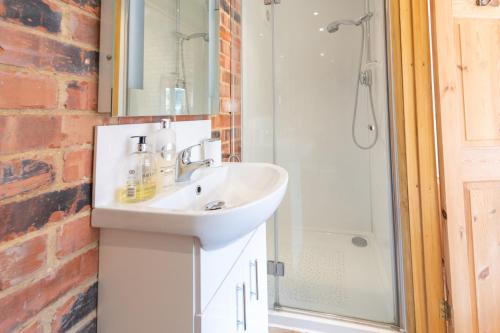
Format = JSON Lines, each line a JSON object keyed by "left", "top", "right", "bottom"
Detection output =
{"left": 241, "top": 0, "right": 276, "bottom": 307}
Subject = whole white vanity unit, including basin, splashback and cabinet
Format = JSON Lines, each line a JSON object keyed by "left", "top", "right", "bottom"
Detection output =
{"left": 92, "top": 120, "right": 288, "bottom": 333}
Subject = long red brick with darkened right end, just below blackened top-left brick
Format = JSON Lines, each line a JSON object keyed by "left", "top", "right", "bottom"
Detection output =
{"left": 0, "top": 26, "right": 99, "bottom": 75}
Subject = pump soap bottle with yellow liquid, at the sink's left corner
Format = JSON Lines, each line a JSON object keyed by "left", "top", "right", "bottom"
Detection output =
{"left": 118, "top": 136, "right": 156, "bottom": 203}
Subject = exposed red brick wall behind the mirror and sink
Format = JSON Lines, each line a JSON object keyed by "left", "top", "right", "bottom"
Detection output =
{"left": 0, "top": 0, "right": 240, "bottom": 333}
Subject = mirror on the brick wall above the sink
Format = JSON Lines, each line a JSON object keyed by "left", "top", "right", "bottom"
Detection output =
{"left": 99, "top": 0, "right": 219, "bottom": 116}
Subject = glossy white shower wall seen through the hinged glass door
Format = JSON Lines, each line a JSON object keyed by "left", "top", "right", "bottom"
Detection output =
{"left": 275, "top": 0, "right": 388, "bottom": 233}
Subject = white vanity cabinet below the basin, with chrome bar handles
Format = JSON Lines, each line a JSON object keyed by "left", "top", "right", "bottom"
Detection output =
{"left": 98, "top": 224, "right": 268, "bottom": 333}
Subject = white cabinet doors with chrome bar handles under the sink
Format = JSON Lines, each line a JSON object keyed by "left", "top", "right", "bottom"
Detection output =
{"left": 201, "top": 225, "right": 268, "bottom": 333}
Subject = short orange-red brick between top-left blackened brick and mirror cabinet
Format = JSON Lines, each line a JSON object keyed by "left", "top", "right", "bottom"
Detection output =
{"left": 65, "top": 11, "right": 99, "bottom": 49}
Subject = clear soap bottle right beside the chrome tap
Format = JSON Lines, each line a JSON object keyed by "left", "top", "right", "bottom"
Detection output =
{"left": 156, "top": 119, "right": 177, "bottom": 188}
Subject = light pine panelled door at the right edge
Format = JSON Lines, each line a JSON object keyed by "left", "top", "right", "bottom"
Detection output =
{"left": 431, "top": 0, "right": 500, "bottom": 333}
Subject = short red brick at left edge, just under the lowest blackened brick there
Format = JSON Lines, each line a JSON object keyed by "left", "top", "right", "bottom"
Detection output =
{"left": 0, "top": 235, "right": 47, "bottom": 290}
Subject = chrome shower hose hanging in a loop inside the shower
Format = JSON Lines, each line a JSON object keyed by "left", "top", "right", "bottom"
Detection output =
{"left": 351, "top": 23, "right": 379, "bottom": 150}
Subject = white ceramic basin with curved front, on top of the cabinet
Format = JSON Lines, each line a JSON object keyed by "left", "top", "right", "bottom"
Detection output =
{"left": 92, "top": 163, "right": 288, "bottom": 250}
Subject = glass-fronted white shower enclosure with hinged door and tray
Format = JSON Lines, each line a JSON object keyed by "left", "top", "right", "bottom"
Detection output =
{"left": 242, "top": 0, "right": 404, "bottom": 332}
